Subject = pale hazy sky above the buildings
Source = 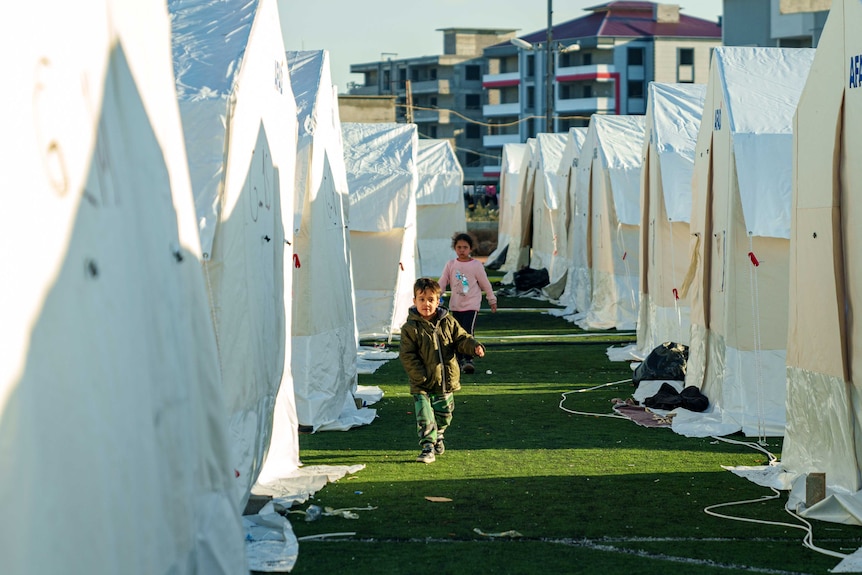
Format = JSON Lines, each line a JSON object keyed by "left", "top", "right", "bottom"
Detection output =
{"left": 277, "top": 0, "right": 722, "bottom": 93}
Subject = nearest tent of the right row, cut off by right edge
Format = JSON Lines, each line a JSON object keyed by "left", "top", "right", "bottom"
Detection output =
{"left": 781, "top": 0, "right": 862, "bottom": 525}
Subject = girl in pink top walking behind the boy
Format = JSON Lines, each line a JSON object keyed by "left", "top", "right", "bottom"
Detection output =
{"left": 440, "top": 232, "right": 497, "bottom": 373}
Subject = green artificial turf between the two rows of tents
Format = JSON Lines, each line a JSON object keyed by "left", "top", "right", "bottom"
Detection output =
{"left": 264, "top": 276, "right": 862, "bottom": 575}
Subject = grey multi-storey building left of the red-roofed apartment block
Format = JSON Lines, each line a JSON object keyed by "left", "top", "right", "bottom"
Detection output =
{"left": 349, "top": 28, "right": 517, "bottom": 183}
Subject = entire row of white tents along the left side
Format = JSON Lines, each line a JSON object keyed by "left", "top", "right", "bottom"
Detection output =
{"left": 0, "top": 0, "right": 465, "bottom": 574}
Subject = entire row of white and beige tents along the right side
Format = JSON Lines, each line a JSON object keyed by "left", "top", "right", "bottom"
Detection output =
{"left": 489, "top": 1, "right": 862, "bottom": 523}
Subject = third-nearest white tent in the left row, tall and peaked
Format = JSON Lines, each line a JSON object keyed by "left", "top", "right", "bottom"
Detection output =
{"left": 287, "top": 50, "right": 375, "bottom": 431}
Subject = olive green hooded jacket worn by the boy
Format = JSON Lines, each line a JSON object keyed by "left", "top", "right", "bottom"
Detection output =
{"left": 398, "top": 307, "right": 479, "bottom": 394}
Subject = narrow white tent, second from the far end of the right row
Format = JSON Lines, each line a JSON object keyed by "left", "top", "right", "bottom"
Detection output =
{"left": 497, "top": 138, "right": 536, "bottom": 284}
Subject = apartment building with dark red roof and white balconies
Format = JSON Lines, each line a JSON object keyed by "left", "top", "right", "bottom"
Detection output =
{"left": 482, "top": 0, "right": 727, "bottom": 178}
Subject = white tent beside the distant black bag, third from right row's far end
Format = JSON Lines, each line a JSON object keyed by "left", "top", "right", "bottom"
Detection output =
{"left": 530, "top": 133, "right": 569, "bottom": 299}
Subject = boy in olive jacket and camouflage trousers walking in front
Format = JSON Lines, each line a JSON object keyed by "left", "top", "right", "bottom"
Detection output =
{"left": 398, "top": 278, "right": 485, "bottom": 463}
